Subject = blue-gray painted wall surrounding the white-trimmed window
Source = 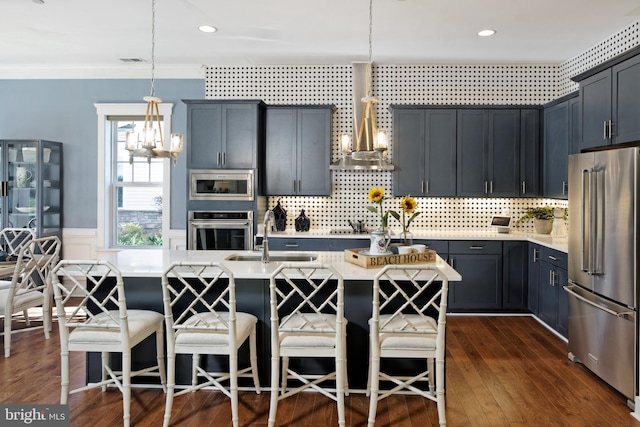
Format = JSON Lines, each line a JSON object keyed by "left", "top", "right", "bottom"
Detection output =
{"left": 0, "top": 79, "right": 205, "bottom": 229}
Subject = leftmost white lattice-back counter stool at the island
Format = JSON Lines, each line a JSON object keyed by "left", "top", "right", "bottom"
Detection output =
{"left": 51, "top": 260, "right": 166, "bottom": 426}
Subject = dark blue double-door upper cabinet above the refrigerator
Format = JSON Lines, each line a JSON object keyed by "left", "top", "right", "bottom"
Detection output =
{"left": 573, "top": 49, "right": 640, "bottom": 150}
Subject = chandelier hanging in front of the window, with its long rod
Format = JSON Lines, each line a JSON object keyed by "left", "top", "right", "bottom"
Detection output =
{"left": 125, "top": 0, "right": 183, "bottom": 165}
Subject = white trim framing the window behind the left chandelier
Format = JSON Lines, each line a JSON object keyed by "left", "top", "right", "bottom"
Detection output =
{"left": 93, "top": 102, "right": 173, "bottom": 249}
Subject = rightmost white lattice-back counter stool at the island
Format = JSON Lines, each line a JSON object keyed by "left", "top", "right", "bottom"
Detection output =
{"left": 367, "top": 264, "right": 449, "bottom": 427}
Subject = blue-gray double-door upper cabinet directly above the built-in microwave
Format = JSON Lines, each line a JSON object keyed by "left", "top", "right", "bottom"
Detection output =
{"left": 184, "top": 100, "right": 264, "bottom": 169}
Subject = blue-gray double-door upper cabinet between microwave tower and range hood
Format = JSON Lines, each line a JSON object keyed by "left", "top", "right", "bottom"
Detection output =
{"left": 263, "top": 105, "right": 334, "bottom": 196}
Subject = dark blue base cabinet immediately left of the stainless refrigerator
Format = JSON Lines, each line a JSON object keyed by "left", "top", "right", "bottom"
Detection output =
{"left": 538, "top": 246, "right": 569, "bottom": 337}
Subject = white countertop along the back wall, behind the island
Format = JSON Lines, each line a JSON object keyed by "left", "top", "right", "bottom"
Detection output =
{"left": 258, "top": 229, "right": 569, "bottom": 253}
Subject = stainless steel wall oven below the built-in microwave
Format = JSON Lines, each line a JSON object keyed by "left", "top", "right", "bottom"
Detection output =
{"left": 187, "top": 211, "right": 253, "bottom": 250}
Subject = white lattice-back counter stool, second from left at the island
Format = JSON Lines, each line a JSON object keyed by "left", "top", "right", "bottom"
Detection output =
{"left": 162, "top": 261, "right": 260, "bottom": 427}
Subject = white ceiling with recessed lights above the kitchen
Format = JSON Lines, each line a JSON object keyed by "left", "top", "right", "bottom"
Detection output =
{"left": 0, "top": 0, "right": 640, "bottom": 77}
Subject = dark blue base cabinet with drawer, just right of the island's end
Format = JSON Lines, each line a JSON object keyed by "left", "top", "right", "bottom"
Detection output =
{"left": 448, "top": 240, "right": 502, "bottom": 312}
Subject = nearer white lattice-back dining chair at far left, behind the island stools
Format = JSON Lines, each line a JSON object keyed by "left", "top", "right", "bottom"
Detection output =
{"left": 0, "top": 236, "right": 60, "bottom": 357}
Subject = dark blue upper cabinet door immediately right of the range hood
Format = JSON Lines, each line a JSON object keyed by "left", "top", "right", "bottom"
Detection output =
{"left": 393, "top": 109, "right": 428, "bottom": 196}
